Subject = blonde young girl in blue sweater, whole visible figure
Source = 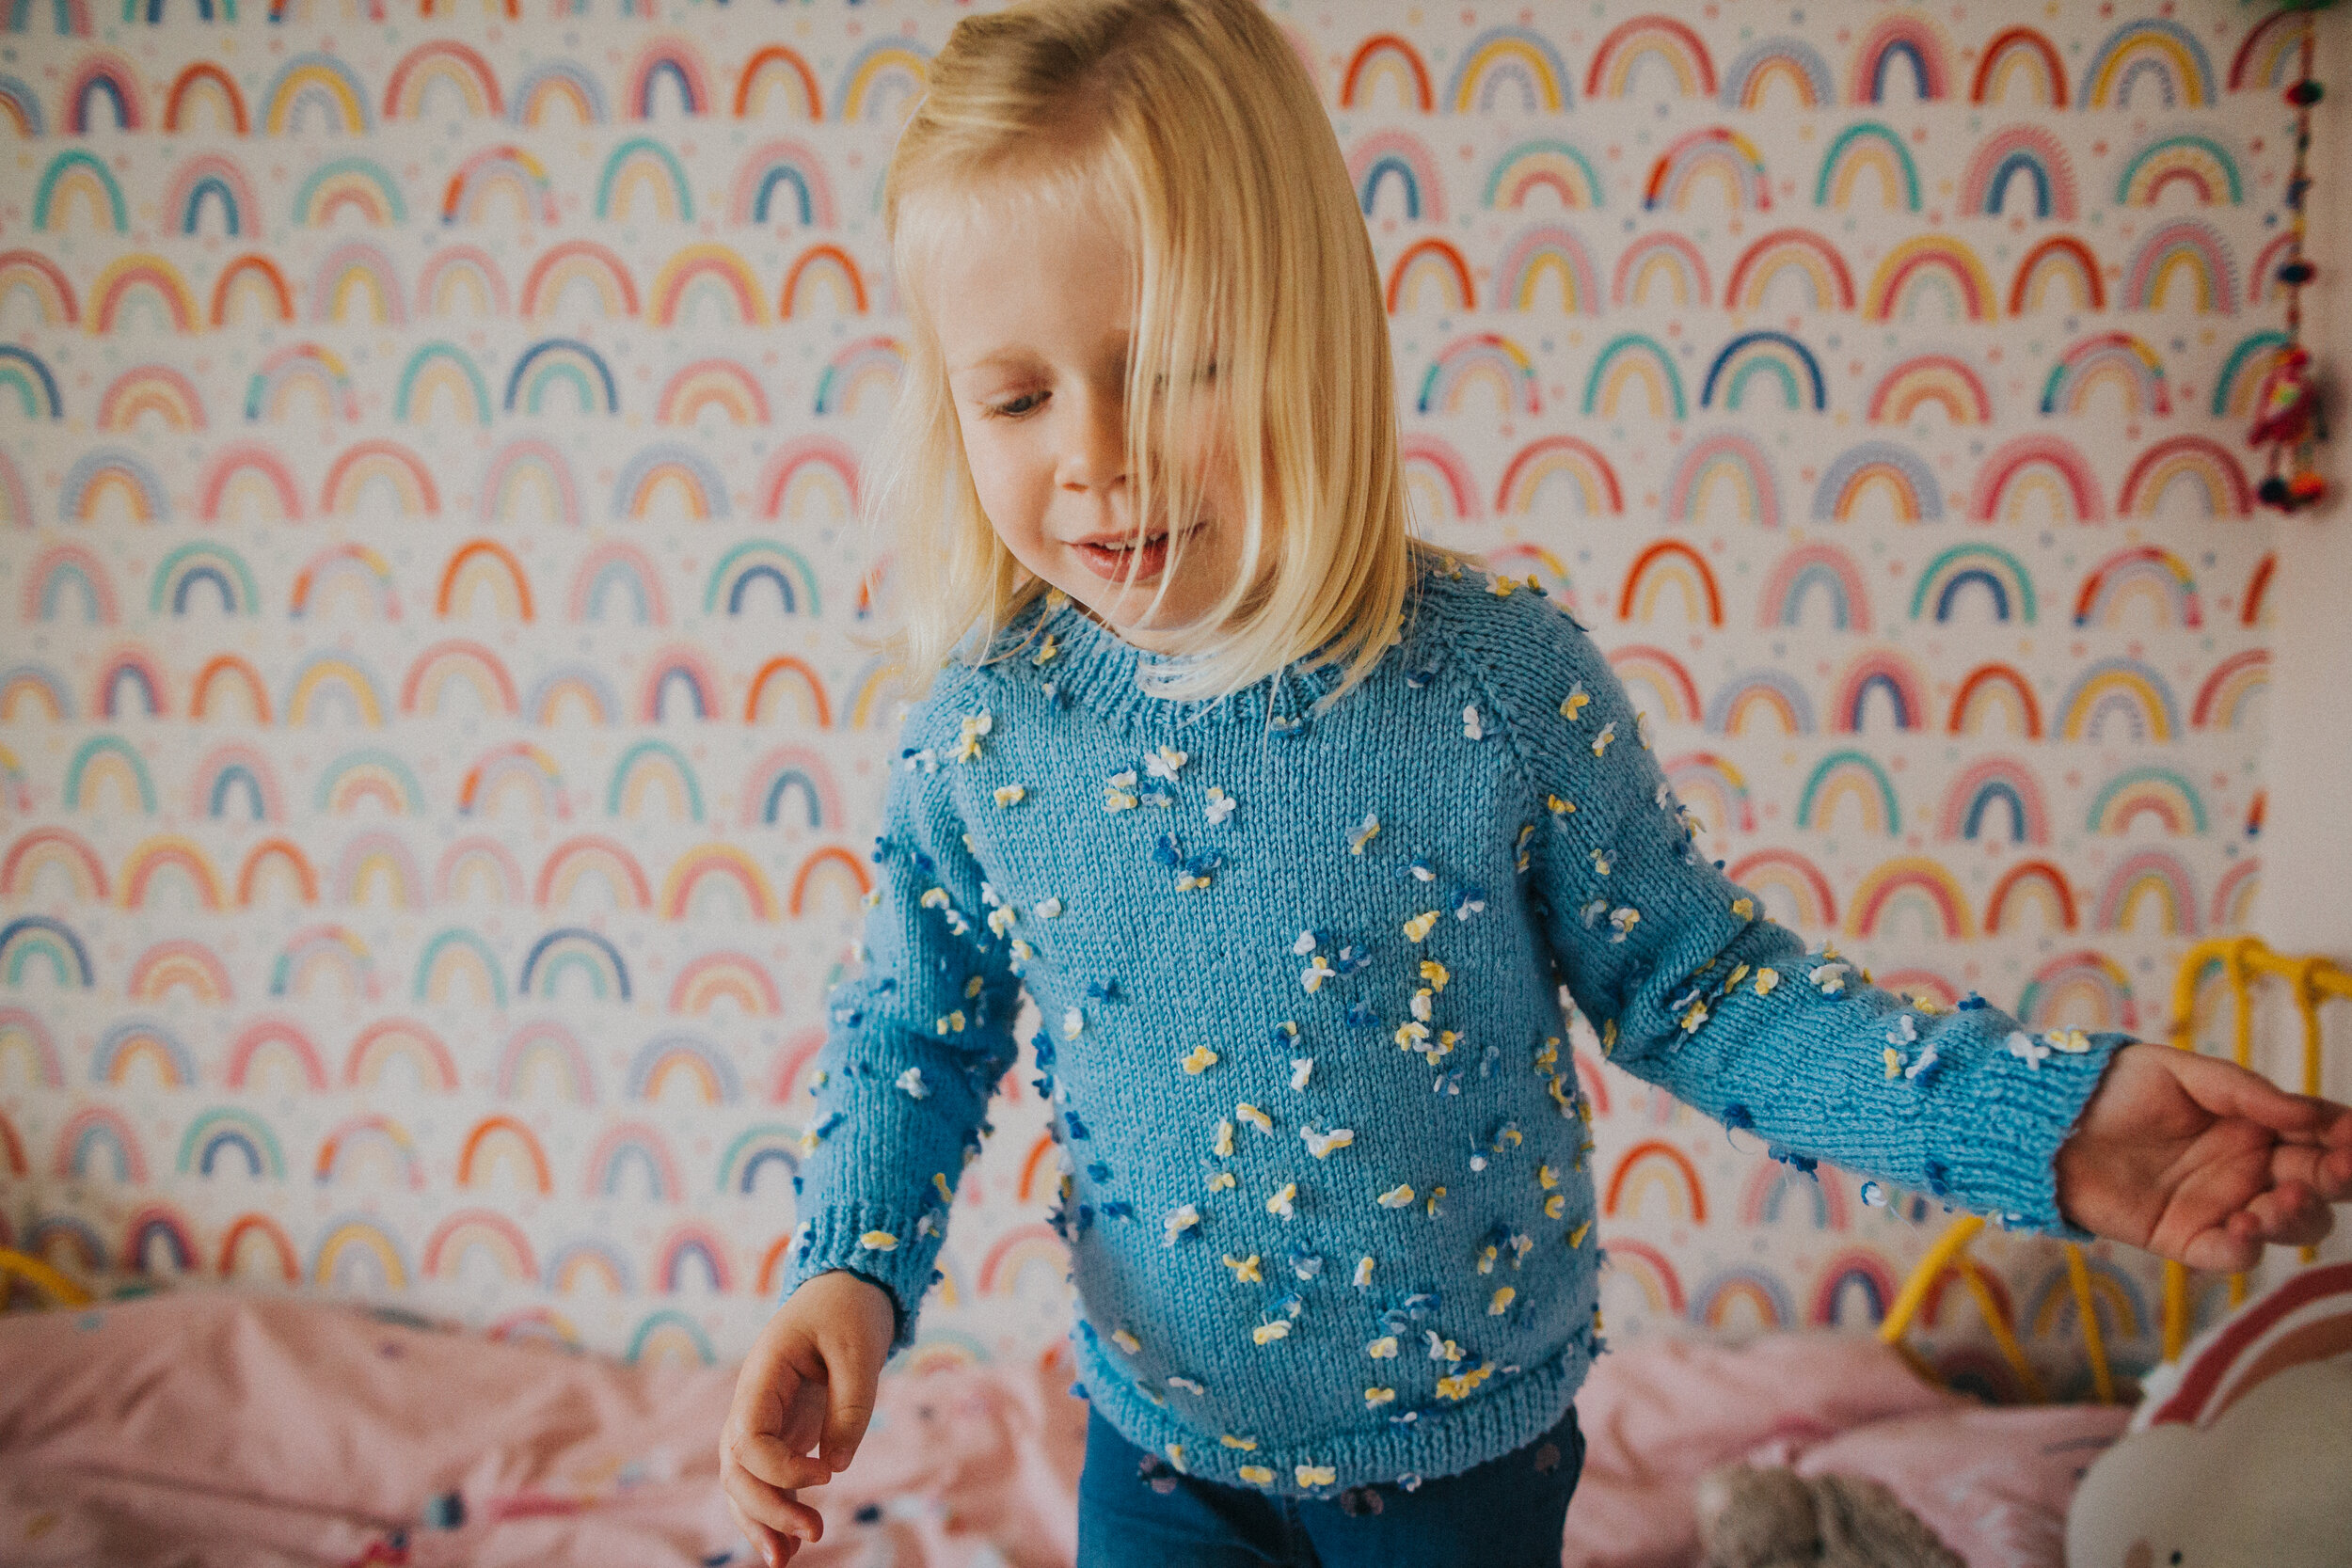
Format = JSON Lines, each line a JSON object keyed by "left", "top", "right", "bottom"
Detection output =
{"left": 723, "top": 0, "right": 2352, "bottom": 1568}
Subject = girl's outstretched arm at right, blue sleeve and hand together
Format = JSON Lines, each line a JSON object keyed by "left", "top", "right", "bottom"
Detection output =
{"left": 1466, "top": 580, "right": 2352, "bottom": 1270}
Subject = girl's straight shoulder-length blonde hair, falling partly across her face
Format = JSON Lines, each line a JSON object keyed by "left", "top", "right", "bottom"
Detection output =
{"left": 864, "top": 0, "right": 1423, "bottom": 696}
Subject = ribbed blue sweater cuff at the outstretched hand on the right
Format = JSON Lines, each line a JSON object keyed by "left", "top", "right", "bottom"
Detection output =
{"left": 1927, "top": 1030, "right": 2131, "bottom": 1242}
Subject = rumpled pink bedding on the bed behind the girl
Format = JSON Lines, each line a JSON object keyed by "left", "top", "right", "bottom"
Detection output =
{"left": 0, "top": 1291, "right": 2126, "bottom": 1568}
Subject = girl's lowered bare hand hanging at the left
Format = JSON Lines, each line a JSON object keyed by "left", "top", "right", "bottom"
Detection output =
{"left": 720, "top": 1270, "right": 898, "bottom": 1568}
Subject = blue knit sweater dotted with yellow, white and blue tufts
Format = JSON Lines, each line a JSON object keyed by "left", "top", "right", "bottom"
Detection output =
{"left": 786, "top": 571, "right": 2124, "bottom": 1496}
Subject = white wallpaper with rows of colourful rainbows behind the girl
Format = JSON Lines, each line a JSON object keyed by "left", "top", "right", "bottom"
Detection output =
{"left": 0, "top": 0, "right": 2300, "bottom": 1385}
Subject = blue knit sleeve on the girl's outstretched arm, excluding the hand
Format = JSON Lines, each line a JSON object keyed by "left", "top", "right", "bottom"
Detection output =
{"left": 1456, "top": 590, "right": 2126, "bottom": 1234}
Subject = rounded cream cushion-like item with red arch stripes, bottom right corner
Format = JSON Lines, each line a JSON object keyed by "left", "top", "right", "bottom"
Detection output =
{"left": 2065, "top": 1262, "right": 2352, "bottom": 1568}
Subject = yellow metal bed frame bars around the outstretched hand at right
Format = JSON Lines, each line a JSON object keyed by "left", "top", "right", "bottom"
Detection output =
{"left": 1880, "top": 936, "right": 2352, "bottom": 1403}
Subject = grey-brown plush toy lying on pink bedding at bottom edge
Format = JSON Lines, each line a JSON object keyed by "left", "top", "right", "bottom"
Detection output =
{"left": 1698, "top": 1465, "right": 1966, "bottom": 1568}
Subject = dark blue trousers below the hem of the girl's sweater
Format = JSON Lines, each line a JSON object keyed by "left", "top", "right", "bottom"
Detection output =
{"left": 1077, "top": 1406, "right": 1585, "bottom": 1568}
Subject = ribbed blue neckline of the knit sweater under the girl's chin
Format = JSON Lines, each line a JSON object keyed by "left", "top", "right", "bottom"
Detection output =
{"left": 995, "top": 574, "right": 1430, "bottom": 734}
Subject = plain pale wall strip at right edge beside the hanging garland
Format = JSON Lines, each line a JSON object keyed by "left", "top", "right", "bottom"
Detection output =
{"left": 2256, "top": 11, "right": 2352, "bottom": 963}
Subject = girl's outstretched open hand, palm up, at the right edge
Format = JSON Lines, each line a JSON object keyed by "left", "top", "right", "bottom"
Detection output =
{"left": 2058, "top": 1044, "right": 2352, "bottom": 1270}
